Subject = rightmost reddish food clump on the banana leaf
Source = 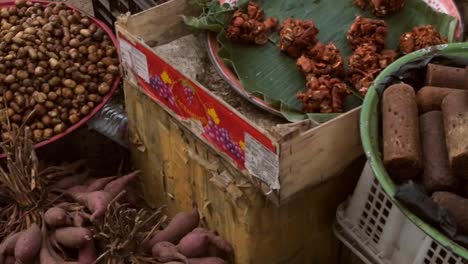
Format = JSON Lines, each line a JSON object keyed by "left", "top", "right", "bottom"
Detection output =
{"left": 400, "top": 25, "right": 447, "bottom": 54}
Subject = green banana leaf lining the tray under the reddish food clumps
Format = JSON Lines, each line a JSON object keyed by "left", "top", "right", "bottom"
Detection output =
{"left": 185, "top": 0, "right": 457, "bottom": 123}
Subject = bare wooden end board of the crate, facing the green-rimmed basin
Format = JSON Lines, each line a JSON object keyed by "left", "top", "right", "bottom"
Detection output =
{"left": 280, "top": 108, "right": 363, "bottom": 202}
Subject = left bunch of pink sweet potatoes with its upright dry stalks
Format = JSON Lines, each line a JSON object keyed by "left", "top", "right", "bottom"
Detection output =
{"left": 0, "top": 128, "right": 152, "bottom": 264}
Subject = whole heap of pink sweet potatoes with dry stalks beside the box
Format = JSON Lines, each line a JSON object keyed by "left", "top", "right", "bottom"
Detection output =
{"left": 0, "top": 128, "right": 233, "bottom": 264}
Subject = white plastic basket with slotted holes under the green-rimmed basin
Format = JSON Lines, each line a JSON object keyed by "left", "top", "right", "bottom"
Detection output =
{"left": 335, "top": 163, "right": 468, "bottom": 264}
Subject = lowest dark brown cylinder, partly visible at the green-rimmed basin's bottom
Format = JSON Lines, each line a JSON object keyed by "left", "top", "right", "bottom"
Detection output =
{"left": 432, "top": 192, "right": 468, "bottom": 234}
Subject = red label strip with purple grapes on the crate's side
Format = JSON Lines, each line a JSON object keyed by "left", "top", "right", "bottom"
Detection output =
{"left": 119, "top": 34, "right": 279, "bottom": 189}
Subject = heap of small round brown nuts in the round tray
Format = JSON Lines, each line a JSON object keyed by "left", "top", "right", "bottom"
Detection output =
{"left": 0, "top": 0, "right": 119, "bottom": 142}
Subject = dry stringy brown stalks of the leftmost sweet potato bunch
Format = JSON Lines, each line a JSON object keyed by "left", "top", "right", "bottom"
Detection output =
{"left": 0, "top": 129, "right": 84, "bottom": 238}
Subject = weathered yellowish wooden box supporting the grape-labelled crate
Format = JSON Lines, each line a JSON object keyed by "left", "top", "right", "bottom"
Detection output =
{"left": 124, "top": 81, "right": 364, "bottom": 264}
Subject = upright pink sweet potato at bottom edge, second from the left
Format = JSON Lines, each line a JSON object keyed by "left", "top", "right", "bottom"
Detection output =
{"left": 15, "top": 224, "right": 42, "bottom": 264}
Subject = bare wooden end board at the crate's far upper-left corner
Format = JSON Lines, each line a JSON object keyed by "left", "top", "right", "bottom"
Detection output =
{"left": 124, "top": 0, "right": 200, "bottom": 46}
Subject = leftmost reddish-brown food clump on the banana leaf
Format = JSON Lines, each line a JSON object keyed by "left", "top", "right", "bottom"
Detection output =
{"left": 226, "top": 2, "right": 278, "bottom": 45}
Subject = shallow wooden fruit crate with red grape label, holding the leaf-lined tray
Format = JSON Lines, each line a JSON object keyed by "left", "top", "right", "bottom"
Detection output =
{"left": 116, "top": 0, "right": 362, "bottom": 205}
